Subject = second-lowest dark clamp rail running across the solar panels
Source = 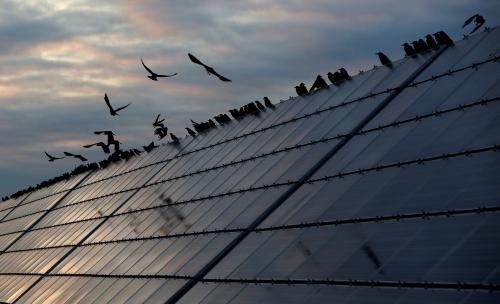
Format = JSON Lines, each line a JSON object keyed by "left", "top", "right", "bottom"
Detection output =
{"left": 0, "top": 205, "right": 500, "bottom": 254}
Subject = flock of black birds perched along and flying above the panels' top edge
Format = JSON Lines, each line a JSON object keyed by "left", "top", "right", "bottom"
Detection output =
{"left": 2, "top": 14, "right": 486, "bottom": 201}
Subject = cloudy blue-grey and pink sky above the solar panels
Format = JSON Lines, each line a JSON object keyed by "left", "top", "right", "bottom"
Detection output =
{"left": 0, "top": 0, "right": 500, "bottom": 196}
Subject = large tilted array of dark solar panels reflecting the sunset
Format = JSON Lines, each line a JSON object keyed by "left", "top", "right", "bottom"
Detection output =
{"left": 0, "top": 28, "right": 500, "bottom": 303}
